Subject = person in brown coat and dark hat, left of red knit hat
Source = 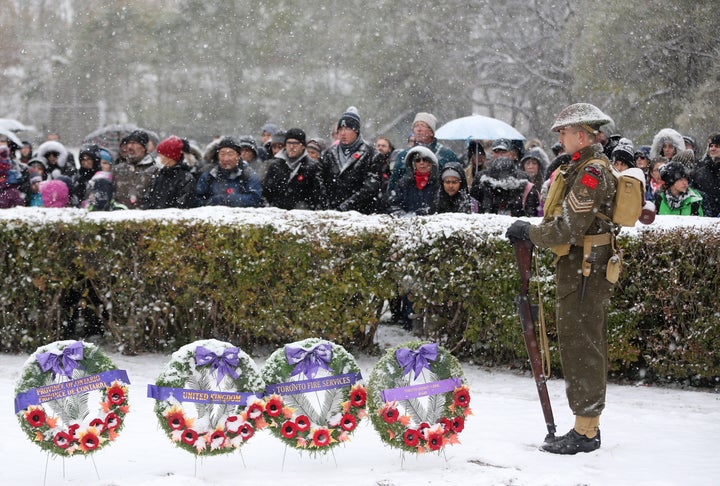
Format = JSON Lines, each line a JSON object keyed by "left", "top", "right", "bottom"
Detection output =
{"left": 113, "top": 130, "right": 157, "bottom": 209}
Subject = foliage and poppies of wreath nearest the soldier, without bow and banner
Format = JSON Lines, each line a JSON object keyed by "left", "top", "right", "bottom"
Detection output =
{"left": 368, "top": 341, "right": 472, "bottom": 453}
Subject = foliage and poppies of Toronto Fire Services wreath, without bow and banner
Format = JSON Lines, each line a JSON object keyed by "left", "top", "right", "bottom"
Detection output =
{"left": 262, "top": 338, "right": 367, "bottom": 453}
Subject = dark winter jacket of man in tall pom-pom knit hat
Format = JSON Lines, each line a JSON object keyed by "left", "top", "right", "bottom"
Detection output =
{"left": 320, "top": 138, "right": 382, "bottom": 214}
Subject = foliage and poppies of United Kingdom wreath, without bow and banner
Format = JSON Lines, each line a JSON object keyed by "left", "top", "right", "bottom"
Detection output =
{"left": 155, "top": 339, "right": 266, "bottom": 456}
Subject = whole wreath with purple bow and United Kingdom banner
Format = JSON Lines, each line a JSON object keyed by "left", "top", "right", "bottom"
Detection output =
{"left": 148, "top": 339, "right": 267, "bottom": 455}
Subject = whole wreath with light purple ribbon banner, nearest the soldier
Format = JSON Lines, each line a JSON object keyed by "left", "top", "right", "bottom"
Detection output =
{"left": 368, "top": 342, "right": 472, "bottom": 453}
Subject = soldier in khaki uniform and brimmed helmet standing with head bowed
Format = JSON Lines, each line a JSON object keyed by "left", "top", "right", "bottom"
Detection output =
{"left": 506, "top": 103, "right": 619, "bottom": 454}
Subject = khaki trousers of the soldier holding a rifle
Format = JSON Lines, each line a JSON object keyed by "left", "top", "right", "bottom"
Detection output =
{"left": 556, "top": 245, "right": 614, "bottom": 417}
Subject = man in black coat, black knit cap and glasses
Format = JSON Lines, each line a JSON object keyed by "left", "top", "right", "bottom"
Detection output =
{"left": 262, "top": 128, "right": 325, "bottom": 209}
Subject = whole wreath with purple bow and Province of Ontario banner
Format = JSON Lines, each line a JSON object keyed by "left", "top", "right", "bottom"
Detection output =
{"left": 15, "top": 341, "right": 130, "bottom": 456}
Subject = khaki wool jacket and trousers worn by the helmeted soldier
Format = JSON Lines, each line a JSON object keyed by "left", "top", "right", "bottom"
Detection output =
{"left": 530, "top": 144, "right": 617, "bottom": 417}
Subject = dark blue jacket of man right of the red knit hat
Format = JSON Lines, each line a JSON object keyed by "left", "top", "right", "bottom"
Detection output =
{"left": 196, "top": 161, "right": 262, "bottom": 208}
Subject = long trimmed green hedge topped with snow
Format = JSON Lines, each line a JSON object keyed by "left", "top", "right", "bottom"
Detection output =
{"left": 0, "top": 208, "right": 720, "bottom": 386}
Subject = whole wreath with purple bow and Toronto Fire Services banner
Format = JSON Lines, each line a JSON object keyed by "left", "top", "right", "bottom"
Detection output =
{"left": 262, "top": 338, "right": 367, "bottom": 453}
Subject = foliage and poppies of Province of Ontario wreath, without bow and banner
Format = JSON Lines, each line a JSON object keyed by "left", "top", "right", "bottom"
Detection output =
{"left": 15, "top": 340, "right": 130, "bottom": 456}
